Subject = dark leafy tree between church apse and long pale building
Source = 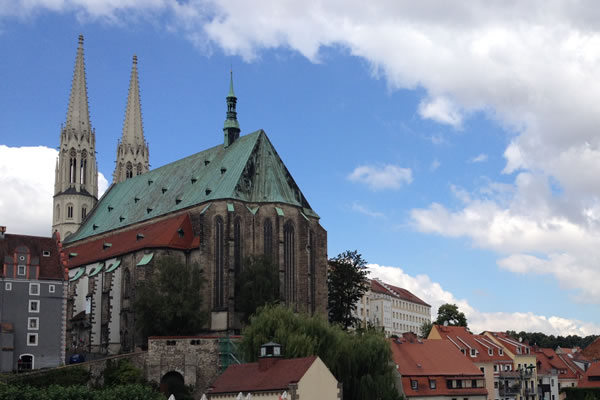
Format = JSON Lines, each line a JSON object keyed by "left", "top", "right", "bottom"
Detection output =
{"left": 327, "top": 250, "right": 369, "bottom": 329}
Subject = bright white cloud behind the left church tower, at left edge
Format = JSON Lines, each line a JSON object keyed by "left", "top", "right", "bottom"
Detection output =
{"left": 0, "top": 145, "right": 107, "bottom": 236}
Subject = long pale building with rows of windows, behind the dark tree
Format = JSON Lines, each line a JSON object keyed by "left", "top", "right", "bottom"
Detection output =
{"left": 354, "top": 278, "right": 431, "bottom": 337}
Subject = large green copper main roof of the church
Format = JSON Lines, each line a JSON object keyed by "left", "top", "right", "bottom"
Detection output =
{"left": 65, "top": 130, "right": 319, "bottom": 243}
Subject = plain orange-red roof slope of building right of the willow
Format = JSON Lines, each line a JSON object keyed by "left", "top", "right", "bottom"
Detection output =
{"left": 390, "top": 339, "right": 483, "bottom": 377}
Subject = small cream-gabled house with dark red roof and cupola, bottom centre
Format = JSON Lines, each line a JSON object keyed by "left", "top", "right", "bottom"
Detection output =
{"left": 206, "top": 343, "right": 342, "bottom": 400}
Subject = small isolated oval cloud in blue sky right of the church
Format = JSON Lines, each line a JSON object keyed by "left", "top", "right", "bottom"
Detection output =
{"left": 347, "top": 164, "right": 412, "bottom": 190}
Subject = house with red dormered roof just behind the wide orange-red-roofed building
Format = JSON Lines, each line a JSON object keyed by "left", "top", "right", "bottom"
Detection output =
{"left": 428, "top": 325, "right": 516, "bottom": 400}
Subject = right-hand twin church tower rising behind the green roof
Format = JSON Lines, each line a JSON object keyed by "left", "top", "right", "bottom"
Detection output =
{"left": 113, "top": 56, "right": 149, "bottom": 183}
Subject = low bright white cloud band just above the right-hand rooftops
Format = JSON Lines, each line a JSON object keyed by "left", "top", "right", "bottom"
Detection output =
{"left": 367, "top": 264, "right": 600, "bottom": 336}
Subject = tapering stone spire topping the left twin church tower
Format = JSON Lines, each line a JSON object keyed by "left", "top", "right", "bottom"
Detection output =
{"left": 65, "top": 35, "right": 90, "bottom": 133}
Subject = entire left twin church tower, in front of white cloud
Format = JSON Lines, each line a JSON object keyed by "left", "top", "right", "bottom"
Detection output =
{"left": 52, "top": 35, "right": 98, "bottom": 240}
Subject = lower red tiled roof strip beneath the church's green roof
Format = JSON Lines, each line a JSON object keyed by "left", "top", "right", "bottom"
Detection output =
{"left": 65, "top": 213, "right": 200, "bottom": 268}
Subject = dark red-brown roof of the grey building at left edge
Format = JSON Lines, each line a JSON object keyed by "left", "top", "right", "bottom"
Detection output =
{"left": 0, "top": 234, "right": 65, "bottom": 280}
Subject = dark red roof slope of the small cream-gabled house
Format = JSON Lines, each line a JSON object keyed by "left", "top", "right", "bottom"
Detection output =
{"left": 209, "top": 356, "right": 317, "bottom": 394}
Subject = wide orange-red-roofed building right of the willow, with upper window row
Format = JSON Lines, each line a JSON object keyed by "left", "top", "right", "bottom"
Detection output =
{"left": 390, "top": 333, "right": 488, "bottom": 400}
